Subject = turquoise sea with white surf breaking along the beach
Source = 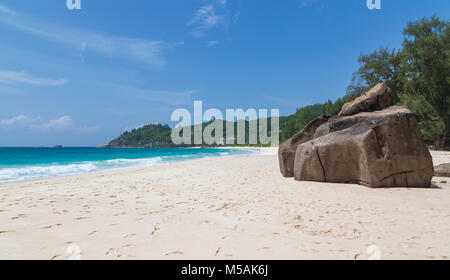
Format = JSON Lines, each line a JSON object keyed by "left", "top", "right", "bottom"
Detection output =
{"left": 0, "top": 148, "right": 254, "bottom": 183}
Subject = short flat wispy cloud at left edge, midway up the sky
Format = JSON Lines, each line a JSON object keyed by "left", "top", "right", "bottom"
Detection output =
{"left": 0, "top": 70, "right": 67, "bottom": 86}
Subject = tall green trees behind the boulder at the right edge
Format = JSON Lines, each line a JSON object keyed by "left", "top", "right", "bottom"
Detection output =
{"left": 352, "top": 17, "right": 450, "bottom": 147}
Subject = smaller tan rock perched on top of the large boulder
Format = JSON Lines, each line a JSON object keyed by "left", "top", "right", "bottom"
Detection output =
{"left": 339, "top": 83, "right": 394, "bottom": 116}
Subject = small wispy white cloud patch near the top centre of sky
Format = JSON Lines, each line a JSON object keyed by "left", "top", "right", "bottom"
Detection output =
{"left": 188, "top": 2, "right": 229, "bottom": 37}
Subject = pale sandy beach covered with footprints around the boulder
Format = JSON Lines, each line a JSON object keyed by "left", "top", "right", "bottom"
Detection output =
{"left": 0, "top": 149, "right": 450, "bottom": 259}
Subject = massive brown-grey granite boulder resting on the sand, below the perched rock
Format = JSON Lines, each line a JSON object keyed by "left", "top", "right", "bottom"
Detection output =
{"left": 279, "top": 85, "right": 433, "bottom": 188}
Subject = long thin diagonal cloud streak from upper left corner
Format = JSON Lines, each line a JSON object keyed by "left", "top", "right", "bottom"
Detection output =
{"left": 0, "top": 5, "right": 170, "bottom": 69}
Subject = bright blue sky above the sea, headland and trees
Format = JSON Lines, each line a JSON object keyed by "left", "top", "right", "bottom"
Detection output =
{"left": 0, "top": 0, "right": 450, "bottom": 146}
